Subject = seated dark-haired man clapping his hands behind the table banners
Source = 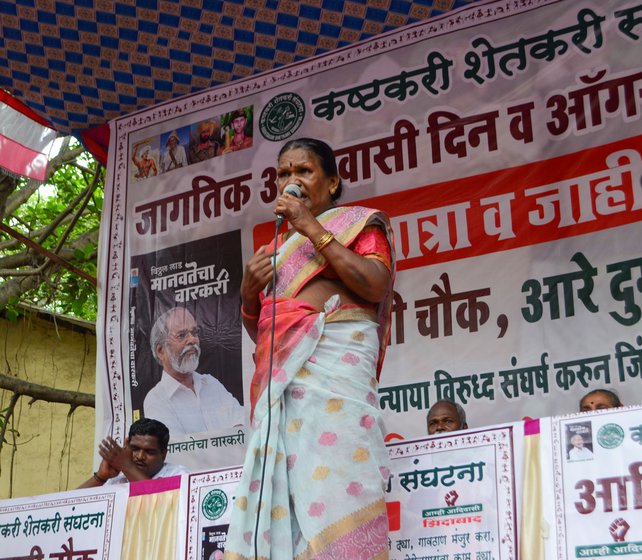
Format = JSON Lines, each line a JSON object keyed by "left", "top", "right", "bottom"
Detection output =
{"left": 79, "top": 418, "right": 189, "bottom": 488}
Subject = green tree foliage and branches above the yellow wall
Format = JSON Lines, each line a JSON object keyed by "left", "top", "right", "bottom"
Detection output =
{"left": 0, "top": 137, "right": 100, "bottom": 318}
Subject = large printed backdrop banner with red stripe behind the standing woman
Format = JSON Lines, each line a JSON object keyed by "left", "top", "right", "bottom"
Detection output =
{"left": 96, "top": 0, "right": 642, "bottom": 470}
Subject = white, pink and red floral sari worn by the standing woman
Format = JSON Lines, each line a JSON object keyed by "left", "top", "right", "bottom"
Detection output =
{"left": 225, "top": 208, "right": 396, "bottom": 560}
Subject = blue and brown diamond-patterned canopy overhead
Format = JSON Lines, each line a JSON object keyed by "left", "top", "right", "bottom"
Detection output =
{"left": 0, "top": 0, "right": 471, "bottom": 160}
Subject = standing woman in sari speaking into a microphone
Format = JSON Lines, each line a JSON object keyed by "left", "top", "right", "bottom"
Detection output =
{"left": 225, "top": 138, "right": 394, "bottom": 560}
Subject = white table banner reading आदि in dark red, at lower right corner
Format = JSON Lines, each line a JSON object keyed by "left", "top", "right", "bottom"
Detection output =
{"left": 551, "top": 408, "right": 642, "bottom": 560}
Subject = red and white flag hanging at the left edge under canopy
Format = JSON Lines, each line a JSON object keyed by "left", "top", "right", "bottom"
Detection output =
{"left": 0, "top": 90, "right": 56, "bottom": 181}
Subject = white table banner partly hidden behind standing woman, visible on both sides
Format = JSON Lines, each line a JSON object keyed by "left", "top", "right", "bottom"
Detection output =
{"left": 179, "top": 423, "right": 523, "bottom": 560}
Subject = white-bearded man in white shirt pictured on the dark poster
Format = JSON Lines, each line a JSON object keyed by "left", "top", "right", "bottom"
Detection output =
{"left": 143, "top": 307, "right": 245, "bottom": 437}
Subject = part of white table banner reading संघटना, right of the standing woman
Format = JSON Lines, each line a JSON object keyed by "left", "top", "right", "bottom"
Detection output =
{"left": 387, "top": 426, "right": 521, "bottom": 560}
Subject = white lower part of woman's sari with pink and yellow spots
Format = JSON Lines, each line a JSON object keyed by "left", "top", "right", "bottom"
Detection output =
{"left": 226, "top": 297, "right": 389, "bottom": 560}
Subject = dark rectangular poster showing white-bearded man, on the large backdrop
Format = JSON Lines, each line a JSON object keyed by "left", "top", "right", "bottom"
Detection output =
{"left": 130, "top": 231, "right": 245, "bottom": 442}
